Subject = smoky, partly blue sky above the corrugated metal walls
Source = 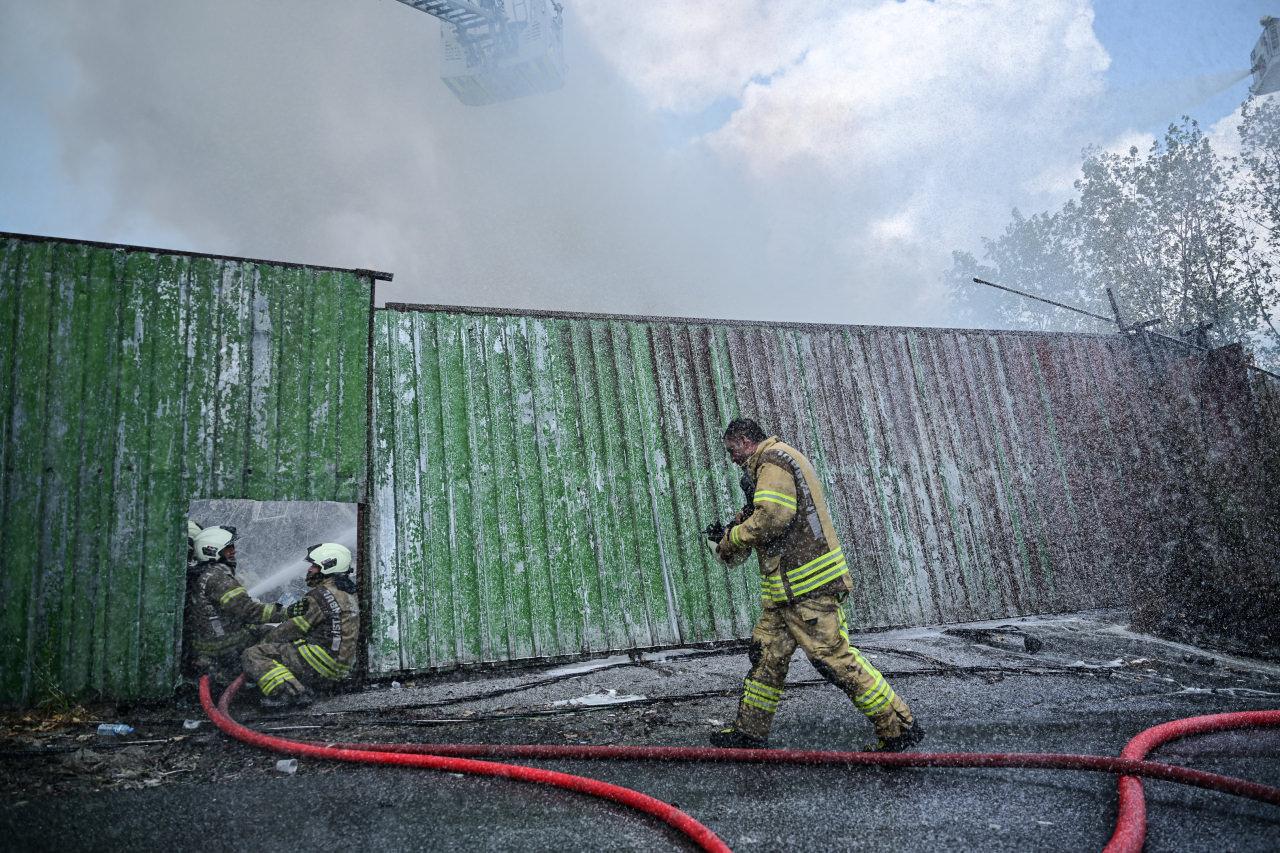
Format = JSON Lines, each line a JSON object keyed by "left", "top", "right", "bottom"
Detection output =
{"left": 0, "top": 0, "right": 1280, "bottom": 324}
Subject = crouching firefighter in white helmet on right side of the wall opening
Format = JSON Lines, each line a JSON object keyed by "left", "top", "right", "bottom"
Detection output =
{"left": 241, "top": 542, "right": 360, "bottom": 706}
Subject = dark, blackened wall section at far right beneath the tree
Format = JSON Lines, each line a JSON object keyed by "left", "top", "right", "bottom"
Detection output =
{"left": 1130, "top": 346, "right": 1280, "bottom": 657}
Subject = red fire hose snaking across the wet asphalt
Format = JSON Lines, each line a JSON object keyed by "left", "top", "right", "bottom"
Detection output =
{"left": 200, "top": 675, "right": 1280, "bottom": 853}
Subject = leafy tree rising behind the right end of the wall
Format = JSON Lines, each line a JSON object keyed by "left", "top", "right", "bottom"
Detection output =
{"left": 947, "top": 99, "right": 1280, "bottom": 366}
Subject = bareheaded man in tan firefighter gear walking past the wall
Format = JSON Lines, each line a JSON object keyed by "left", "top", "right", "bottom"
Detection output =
{"left": 708, "top": 419, "right": 924, "bottom": 752}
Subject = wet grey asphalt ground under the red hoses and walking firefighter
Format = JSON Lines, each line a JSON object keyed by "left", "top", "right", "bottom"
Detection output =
{"left": 0, "top": 612, "right": 1280, "bottom": 853}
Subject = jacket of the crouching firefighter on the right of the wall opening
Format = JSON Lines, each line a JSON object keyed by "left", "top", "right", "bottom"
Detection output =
{"left": 262, "top": 578, "right": 360, "bottom": 681}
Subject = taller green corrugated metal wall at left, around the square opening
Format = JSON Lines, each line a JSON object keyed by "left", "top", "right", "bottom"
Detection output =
{"left": 0, "top": 234, "right": 372, "bottom": 703}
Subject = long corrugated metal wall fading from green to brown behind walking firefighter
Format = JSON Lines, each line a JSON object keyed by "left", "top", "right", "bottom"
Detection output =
{"left": 370, "top": 306, "right": 1172, "bottom": 672}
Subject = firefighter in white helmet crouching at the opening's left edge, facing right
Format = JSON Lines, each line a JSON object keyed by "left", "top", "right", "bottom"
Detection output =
{"left": 183, "top": 521, "right": 280, "bottom": 684}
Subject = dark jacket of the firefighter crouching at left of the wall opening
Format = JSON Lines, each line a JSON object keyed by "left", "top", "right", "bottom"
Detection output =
{"left": 183, "top": 561, "right": 279, "bottom": 657}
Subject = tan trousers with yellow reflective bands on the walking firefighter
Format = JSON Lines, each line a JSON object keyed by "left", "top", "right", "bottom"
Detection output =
{"left": 733, "top": 594, "right": 913, "bottom": 738}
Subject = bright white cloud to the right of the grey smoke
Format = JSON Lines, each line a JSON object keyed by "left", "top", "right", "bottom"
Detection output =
{"left": 609, "top": 0, "right": 1110, "bottom": 321}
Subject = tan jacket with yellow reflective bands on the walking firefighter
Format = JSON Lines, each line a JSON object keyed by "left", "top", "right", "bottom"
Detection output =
{"left": 717, "top": 435, "right": 852, "bottom": 607}
